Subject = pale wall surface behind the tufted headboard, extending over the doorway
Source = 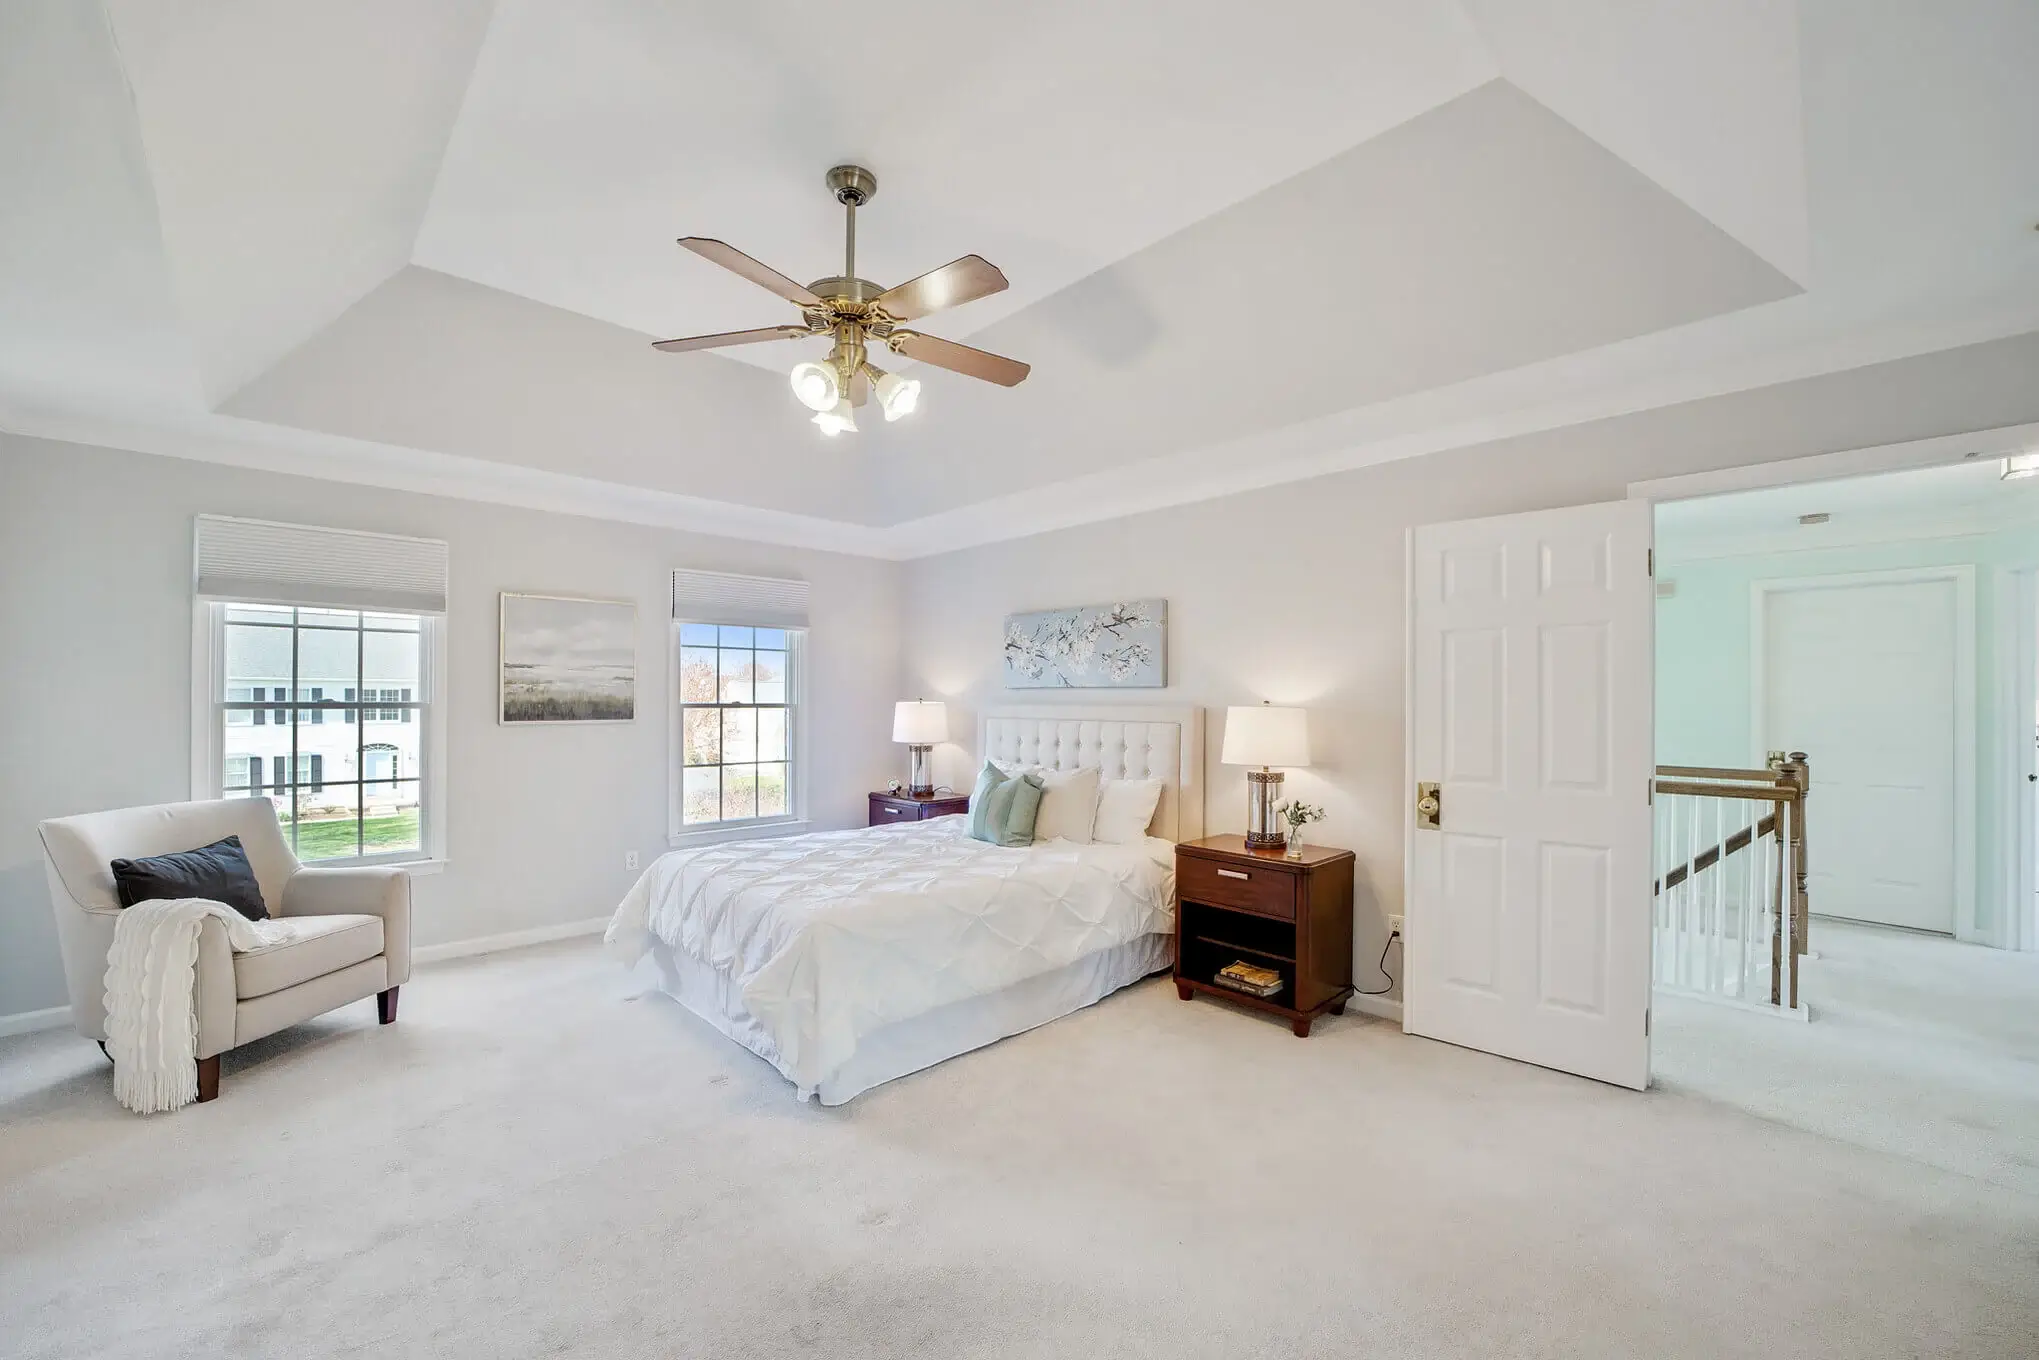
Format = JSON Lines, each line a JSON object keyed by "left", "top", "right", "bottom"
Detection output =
{"left": 905, "top": 336, "right": 2039, "bottom": 995}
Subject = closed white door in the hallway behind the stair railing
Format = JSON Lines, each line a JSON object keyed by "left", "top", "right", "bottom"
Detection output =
{"left": 1756, "top": 575, "right": 1966, "bottom": 934}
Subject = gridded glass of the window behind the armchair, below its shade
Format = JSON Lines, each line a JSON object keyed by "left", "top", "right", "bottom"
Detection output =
{"left": 206, "top": 601, "right": 438, "bottom": 862}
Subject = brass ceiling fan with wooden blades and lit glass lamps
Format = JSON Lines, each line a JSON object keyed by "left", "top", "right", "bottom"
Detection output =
{"left": 652, "top": 165, "right": 1030, "bottom": 434}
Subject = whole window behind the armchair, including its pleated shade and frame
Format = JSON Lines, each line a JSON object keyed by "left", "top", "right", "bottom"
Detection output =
{"left": 192, "top": 516, "right": 445, "bottom": 862}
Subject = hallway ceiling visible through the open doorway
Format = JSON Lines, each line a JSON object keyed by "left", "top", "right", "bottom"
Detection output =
{"left": 1656, "top": 457, "right": 2039, "bottom": 563}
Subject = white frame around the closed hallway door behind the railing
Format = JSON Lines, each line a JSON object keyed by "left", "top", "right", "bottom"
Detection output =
{"left": 1749, "top": 563, "right": 1973, "bottom": 944}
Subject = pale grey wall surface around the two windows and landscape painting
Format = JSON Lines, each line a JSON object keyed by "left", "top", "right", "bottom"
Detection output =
{"left": 0, "top": 434, "right": 903, "bottom": 1015}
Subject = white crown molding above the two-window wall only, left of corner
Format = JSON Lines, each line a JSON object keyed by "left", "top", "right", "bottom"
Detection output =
{"left": 0, "top": 408, "right": 897, "bottom": 559}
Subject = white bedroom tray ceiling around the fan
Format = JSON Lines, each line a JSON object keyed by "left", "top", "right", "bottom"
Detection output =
{"left": 0, "top": 0, "right": 2039, "bottom": 542}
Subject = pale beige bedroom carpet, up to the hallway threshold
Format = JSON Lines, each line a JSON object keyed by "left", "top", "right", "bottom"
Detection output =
{"left": 0, "top": 944, "right": 2039, "bottom": 1360}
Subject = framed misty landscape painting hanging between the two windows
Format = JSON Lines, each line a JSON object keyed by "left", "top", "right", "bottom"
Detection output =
{"left": 502, "top": 593, "right": 636, "bottom": 724}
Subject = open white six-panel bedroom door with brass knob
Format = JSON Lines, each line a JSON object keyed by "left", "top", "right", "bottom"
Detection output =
{"left": 1403, "top": 502, "right": 1656, "bottom": 1091}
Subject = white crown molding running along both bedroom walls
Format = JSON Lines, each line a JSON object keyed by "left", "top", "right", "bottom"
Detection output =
{"left": 0, "top": 300, "right": 2039, "bottom": 561}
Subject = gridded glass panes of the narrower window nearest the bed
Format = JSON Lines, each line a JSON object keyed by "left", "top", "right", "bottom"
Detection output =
{"left": 675, "top": 622, "right": 799, "bottom": 830}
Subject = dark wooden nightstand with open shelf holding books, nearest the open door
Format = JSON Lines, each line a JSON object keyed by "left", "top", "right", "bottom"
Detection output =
{"left": 1174, "top": 836, "right": 1354, "bottom": 1038}
